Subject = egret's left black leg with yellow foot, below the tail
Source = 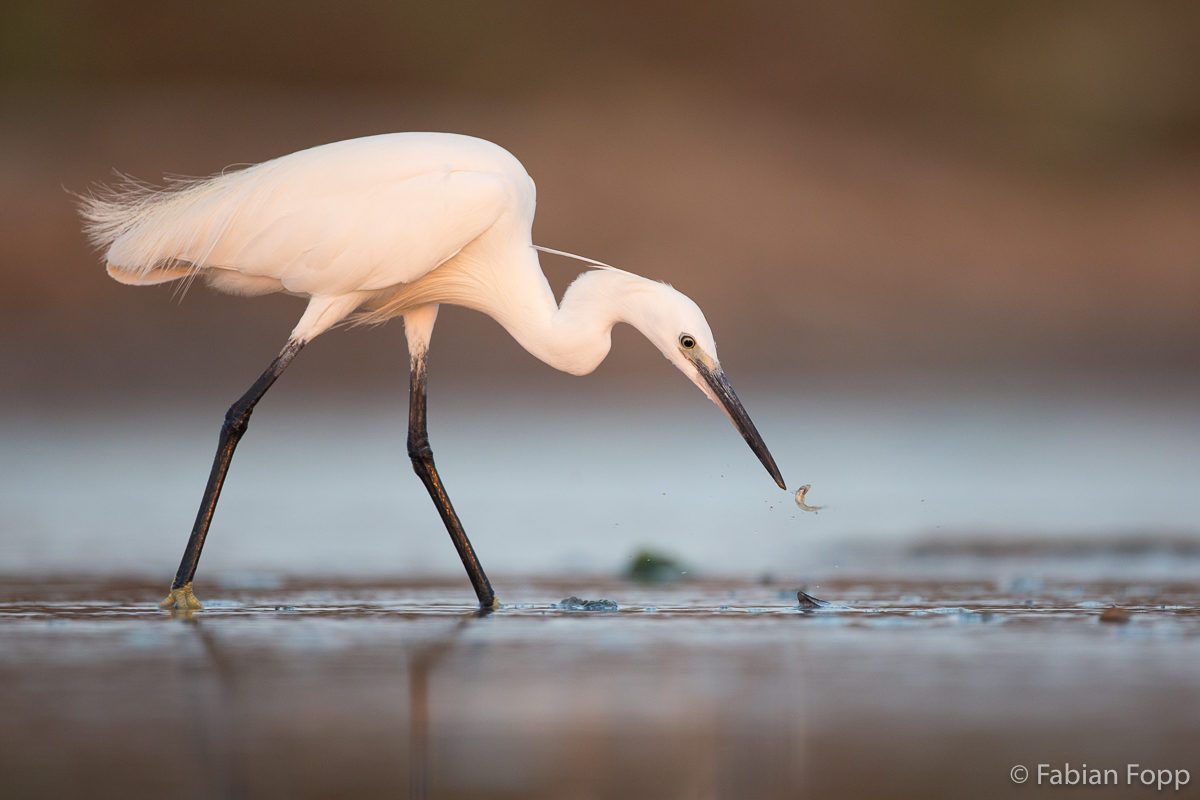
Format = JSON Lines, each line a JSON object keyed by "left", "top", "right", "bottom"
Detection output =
{"left": 161, "top": 338, "right": 304, "bottom": 609}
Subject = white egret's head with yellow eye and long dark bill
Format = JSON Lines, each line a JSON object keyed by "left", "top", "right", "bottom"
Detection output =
{"left": 625, "top": 278, "right": 786, "bottom": 488}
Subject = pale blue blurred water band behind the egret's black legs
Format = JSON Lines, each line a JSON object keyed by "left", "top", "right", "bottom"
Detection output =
{"left": 7, "top": 379, "right": 1200, "bottom": 579}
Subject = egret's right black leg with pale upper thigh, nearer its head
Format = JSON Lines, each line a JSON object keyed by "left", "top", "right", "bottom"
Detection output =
{"left": 404, "top": 306, "right": 499, "bottom": 608}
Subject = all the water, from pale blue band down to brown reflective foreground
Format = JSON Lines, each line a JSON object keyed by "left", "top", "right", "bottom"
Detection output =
{"left": 0, "top": 381, "right": 1200, "bottom": 800}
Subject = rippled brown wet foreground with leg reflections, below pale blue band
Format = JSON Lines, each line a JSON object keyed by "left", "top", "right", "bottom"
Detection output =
{"left": 0, "top": 578, "right": 1200, "bottom": 798}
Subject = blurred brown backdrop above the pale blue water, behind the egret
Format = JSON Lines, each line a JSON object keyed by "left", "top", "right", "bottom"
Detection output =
{"left": 0, "top": 0, "right": 1200, "bottom": 403}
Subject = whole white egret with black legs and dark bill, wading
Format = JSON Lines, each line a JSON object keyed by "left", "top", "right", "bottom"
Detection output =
{"left": 82, "top": 133, "right": 784, "bottom": 608}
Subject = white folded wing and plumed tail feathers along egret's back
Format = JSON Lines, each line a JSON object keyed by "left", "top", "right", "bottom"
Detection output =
{"left": 83, "top": 133, "right": 533, "bottom": 295}
